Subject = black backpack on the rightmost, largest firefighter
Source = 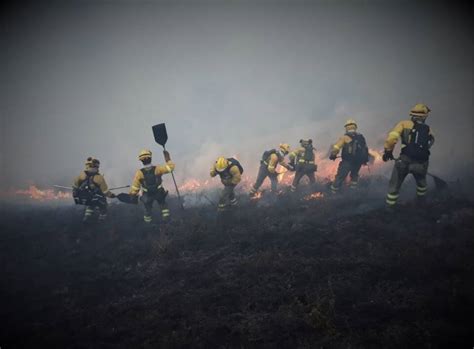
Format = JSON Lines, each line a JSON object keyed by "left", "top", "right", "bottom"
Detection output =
{"left": 402, "top": 122, "right": 432, "bottom": 161}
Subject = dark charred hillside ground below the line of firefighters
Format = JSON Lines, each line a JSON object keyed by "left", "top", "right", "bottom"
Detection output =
{"left": 0, "top": 181, "right": 474, "bottom": 349}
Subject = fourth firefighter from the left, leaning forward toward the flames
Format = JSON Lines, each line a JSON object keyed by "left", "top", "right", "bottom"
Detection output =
{"left": 250, "top": 143, "right": 292, "bottom": 196}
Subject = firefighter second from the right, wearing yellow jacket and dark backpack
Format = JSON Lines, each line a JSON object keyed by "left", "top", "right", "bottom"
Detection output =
{"left": 329, "top": 119, "right": 369, "bottom": 194}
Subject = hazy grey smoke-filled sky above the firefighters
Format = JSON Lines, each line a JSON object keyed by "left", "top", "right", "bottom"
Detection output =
{"left": 0, "top": 2, "right": 474, "bottom": 188}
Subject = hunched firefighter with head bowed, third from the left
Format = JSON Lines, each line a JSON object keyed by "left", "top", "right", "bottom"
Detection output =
{"left": 210, "top": 157, "right": 244, "bottom": 211}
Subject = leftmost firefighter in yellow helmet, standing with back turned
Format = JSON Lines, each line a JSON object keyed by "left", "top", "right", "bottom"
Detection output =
{"left": 72, "top": 157, "right": 115, "bottom": 222}
